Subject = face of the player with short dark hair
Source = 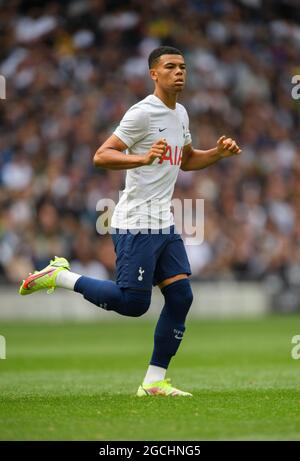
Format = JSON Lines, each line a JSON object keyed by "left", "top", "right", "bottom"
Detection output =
{"left": 150, "top": 54, "right": 186, "bottom": 93}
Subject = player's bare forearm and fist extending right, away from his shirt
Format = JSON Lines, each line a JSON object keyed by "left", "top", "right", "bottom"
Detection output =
{"left": 180, "top": 136, "right": 242, "bottom": 171}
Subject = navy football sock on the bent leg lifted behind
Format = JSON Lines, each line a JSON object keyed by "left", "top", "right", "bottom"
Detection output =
{"left": 74, "top": 276, "right": 151, "bottom": 317}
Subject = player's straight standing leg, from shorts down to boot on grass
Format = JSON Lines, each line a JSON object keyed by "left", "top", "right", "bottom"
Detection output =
{"left": 137, "top": 230, "right": 193, "bottom": 396}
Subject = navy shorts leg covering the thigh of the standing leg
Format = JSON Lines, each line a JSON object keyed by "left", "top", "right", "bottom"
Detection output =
{"left": 153, "top": 235, "right": 192, "bottom": 286}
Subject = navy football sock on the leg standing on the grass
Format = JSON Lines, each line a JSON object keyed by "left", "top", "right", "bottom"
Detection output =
{"left": 150, "top": 278, "right": 193, "bottom": 368}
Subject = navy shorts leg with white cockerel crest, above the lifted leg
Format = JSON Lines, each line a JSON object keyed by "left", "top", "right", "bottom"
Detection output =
{"left": 112, "top": 232, "right": 155, "bottom": 290}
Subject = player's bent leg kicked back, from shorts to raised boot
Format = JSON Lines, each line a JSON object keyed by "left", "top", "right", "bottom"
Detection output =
{"left": 20, "top": 233, "right": 154, "bottom": 317}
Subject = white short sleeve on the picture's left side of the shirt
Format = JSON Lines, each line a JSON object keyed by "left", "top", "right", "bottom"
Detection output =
{"left": 114, "top": 108, "right": 149, "bottom": 148}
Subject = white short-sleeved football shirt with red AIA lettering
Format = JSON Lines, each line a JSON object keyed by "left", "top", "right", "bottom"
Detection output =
{"left": 111, "top": 94, "right": 192, "bottom": 229}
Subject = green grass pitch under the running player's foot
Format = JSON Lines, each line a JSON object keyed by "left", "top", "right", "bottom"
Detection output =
{"left": 0, "top": 316, "right": 300, "bottom": 441}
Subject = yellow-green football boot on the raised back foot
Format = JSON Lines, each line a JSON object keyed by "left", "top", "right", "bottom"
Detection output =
{"left": 19, "top": 256, "right": 70, "bottom": 295}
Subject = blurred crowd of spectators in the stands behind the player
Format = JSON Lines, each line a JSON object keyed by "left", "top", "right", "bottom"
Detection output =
{"left": 0, "top": 0, "right": 300, "bottom": 306}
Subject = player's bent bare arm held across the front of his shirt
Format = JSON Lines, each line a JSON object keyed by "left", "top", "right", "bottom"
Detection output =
{"left": 94, "top": 134, "right": 167, "bottom": 170}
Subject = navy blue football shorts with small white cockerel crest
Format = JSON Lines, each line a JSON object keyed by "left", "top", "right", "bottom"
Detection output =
{"left": 111, "top": 226, "right": 191, "bottom": 290}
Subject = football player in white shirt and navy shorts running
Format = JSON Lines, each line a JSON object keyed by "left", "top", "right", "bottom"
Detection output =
{"left": 20, "top": 46, "right": 241, "bottom": 397}
